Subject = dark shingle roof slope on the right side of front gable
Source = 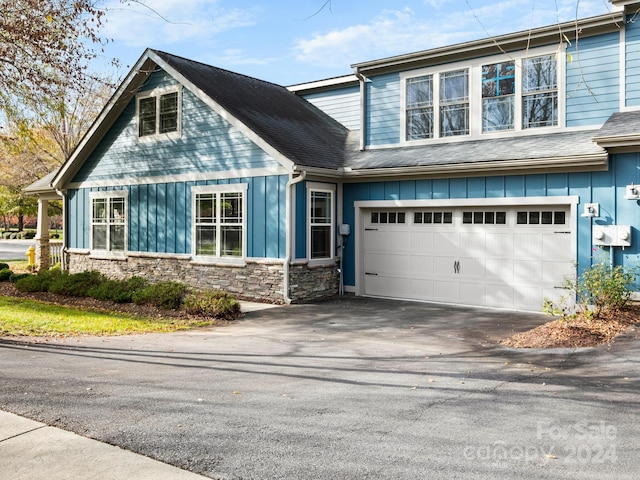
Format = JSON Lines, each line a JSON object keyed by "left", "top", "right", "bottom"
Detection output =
{"left": 154, "top": 50, "right": 348, "bottom": 169}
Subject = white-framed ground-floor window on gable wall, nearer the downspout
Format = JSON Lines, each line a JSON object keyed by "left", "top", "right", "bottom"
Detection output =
{"left": 191, "top": 183, "right": 247, "bottom": 261}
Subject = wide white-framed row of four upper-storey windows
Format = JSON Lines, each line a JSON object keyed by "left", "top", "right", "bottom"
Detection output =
{"left": 401, "top": 48, "right": 565, "bottom": 142}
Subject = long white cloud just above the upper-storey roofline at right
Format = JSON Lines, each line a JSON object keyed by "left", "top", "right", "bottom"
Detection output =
{"left": 294, "top": 0, "right": 616, "bottom": 66}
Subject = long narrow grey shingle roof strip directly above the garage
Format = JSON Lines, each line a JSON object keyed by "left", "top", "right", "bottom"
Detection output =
{"left": 345, "top": 130, "right": 606, "bottom": 170}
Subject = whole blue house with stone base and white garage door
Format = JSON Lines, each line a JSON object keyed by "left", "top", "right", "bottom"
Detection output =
{"left": 32, "top": 0, "right": 640, "bottom": 310}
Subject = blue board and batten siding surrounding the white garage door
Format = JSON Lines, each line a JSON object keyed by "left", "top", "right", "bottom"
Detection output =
{"left": 342, "top": 153, "right": 640, "bottom": 286}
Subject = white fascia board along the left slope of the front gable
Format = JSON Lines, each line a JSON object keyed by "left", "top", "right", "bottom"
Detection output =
{"left": 51, "top": 49, "right": 157, "bottom": 189}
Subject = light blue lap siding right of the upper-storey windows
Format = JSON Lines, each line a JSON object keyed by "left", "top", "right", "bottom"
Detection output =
{"left": 566, "top": 32, "right": 620, "bottom": 127}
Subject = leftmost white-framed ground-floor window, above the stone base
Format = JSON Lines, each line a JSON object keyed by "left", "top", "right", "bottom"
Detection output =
{"left": 89, "top": 191, "right": 128, "bottom": 253}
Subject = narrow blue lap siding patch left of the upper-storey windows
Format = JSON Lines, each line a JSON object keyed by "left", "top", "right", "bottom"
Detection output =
{"left": 365, "top": 73, "right": 401, "bottom": 146}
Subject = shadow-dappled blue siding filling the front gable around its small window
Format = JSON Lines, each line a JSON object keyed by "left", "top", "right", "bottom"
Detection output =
{"left": 72, "top": 72, "right": 279, "bottom": 185}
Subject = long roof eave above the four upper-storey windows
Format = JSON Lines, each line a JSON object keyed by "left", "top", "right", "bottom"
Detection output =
{"left": 351, "top": 11, "right": 624, "bottom": 74}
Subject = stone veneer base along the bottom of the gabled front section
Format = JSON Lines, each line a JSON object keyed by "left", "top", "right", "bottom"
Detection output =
{"left": 66, "top": 252, "right": 339, "bottom": 304}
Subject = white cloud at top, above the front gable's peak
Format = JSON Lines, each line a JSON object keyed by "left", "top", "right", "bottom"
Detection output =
{"left": 104, "top": 0, "right": 259, "bottom": 49}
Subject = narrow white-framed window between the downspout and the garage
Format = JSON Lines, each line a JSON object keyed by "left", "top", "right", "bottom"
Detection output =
{"left": 307, "top": 182, "right": 336, "bottom": 260}
